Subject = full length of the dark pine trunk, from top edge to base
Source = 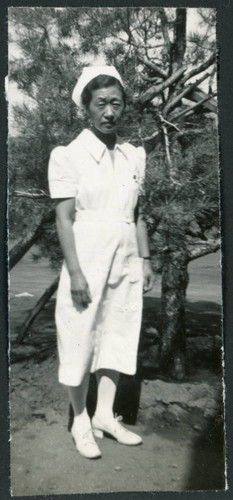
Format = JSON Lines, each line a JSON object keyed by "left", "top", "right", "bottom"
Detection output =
{"left": 160, "top": 8, "right": 188, "bottom": 380}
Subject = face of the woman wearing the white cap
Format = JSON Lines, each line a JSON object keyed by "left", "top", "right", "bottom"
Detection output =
{"left": 88, "top": 85, "right": 125, "bottom": 134}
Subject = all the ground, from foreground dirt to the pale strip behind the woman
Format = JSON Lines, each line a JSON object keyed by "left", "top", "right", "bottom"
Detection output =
{"left": 10, "top": 250, "right": 225, "bottom": 496}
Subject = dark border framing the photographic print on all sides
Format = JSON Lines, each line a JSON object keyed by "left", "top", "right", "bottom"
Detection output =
{"left": 0, "top": 0, "right": 233, "bottom": 500}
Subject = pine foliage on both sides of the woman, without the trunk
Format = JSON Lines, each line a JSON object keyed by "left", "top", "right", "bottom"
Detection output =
{"left": 9, "top": 7, "right": 218, "bottom": 262}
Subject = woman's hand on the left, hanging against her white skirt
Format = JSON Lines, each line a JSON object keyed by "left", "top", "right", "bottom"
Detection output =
{"left": 70, "top": 271, "right": 91, "bottom": 311}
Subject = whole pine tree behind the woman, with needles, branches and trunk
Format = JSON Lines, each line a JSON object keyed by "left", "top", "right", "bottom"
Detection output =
{"left": 10, "top": 7, "right": 219, "bottom": 378}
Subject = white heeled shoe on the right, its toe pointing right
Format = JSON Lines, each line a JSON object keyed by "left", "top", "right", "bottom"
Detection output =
{"left": 92, "top": 415, "right": 142, "bottom": 446}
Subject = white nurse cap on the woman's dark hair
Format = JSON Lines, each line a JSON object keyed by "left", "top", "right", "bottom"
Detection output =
{"left": 72, "top": 66, "right": 124, "bottom": 108}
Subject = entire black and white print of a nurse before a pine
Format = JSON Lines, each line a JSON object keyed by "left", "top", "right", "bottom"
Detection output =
{"left": 6, "top": 6, "right": 227, "bottom": 497}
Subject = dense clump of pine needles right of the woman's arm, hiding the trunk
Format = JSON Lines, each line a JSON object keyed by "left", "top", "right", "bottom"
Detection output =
{"left": 145, "top": 113, "right": 219, "bottom": 269}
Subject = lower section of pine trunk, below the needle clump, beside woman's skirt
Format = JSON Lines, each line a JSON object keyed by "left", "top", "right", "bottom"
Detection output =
{"left": 160, "top": 224, "right": 188, "bottom": 380}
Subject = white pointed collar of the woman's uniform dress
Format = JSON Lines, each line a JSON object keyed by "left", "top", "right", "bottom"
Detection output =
{"left": 79, "top": 128, "right": 128, "bottom": 163}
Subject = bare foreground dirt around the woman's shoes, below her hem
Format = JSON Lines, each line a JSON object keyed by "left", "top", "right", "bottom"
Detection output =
{"left": 11, "top": 357, "right": 224, "bottom": 496}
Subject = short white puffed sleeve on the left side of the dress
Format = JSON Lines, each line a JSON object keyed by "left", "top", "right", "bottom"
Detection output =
{"left": 48, "top": 146, "right": 77, "bottom": 198}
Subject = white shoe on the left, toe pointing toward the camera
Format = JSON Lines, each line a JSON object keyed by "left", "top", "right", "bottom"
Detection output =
{"left": 71, "top": 424, "right": 101, "bottom": 458}
